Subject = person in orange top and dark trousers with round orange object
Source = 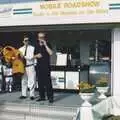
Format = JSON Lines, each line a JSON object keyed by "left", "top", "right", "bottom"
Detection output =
{"left": 3, "top": 46, "right": 25, "bottom": 91}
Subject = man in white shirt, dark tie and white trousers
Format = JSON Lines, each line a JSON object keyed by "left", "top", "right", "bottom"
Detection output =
{"left": 19, "top": 36, "right": 36, "bottom": 100}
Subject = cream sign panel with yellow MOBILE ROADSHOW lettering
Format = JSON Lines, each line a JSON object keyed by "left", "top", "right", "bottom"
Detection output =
{"left": 33, "top": 0, "right": 109, "bottom": 16}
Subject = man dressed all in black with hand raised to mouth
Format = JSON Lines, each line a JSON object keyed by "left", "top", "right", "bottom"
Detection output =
{"left": 34, "top": 32, "right": 53, "bottom": 103}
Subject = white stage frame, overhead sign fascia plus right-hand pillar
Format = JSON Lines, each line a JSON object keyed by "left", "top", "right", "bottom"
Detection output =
{"left": 0, "top": 0, "right": 120, "bottom": 94}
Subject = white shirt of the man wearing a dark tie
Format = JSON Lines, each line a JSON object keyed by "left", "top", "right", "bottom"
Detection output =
{"left": 19, "top": 45, "right": 36, "bottom": 65}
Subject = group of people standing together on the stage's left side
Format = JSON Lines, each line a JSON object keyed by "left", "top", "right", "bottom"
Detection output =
{"left": 0, "top": 32, "right": 53, "bottom": 103}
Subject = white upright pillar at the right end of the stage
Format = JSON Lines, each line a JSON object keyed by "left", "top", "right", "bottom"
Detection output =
{"left": 111, "top": 28, "right": 120, "bottom": 96}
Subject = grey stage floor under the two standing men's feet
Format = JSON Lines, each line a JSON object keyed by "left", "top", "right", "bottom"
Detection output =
{"left": 0, "top": 92, "right": 100, "bottom": 120}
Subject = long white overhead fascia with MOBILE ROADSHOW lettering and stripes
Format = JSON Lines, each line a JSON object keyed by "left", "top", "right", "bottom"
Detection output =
{"left": 0, "top": 0, "right": 120, "bottom": 26}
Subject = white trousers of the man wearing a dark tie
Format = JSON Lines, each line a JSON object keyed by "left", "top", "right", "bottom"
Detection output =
{"left": 22, "top": 66, "right": 36, "bottom": 97}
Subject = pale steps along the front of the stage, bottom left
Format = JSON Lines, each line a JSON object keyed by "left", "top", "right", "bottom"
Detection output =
{"left": 0, "top": 103, "right": 77, "bottom": 120}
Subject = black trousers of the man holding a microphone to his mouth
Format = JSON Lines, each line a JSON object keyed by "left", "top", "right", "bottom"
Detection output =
{"left": 38, "top": 69, "right": 53, "bottom": 99}
